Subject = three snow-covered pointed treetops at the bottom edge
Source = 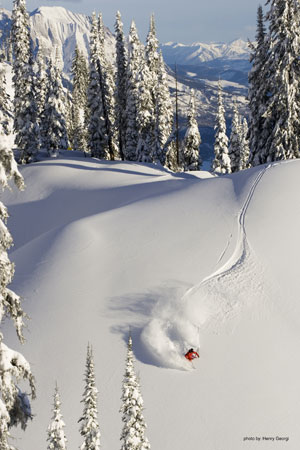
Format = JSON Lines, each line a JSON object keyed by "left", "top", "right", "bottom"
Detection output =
{"left": 47, "top": 336, "right": 150, "bottom": 450}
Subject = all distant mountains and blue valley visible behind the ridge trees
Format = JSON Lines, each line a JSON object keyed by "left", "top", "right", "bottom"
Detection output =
{"left": 0, "top": 6, "right": 250, "bottom": 163}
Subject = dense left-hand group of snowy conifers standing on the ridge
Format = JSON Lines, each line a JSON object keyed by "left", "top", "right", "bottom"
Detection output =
{"left": 7, "top": 0, "right": 201, "bottom": 170}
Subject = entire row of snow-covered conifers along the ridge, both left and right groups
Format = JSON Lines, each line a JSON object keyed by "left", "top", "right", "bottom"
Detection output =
{"left": 0, "top": 0, "right": 300, "bottom": 173}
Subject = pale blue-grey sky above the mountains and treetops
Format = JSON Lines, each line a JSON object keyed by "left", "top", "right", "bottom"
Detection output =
{"left": 0, "top": 0, "right": 264, "bottom": 44}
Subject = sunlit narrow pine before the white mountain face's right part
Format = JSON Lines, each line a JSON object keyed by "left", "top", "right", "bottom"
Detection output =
{"left": 70, "top": 45, "right": 88, "bottom": 151}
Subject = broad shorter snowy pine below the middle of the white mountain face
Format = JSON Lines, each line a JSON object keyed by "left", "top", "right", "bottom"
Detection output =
{"left": 43, "top": 57, "right": 68, "bottom": 156}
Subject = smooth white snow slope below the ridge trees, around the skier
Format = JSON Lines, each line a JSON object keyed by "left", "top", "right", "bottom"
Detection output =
{"left": 4, "top": 153, "right": 300, "bottom": 450}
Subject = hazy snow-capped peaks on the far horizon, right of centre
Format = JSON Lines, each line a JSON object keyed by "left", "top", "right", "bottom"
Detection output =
{"left": 161, "top": 39, "right": 249, "bottom": 65}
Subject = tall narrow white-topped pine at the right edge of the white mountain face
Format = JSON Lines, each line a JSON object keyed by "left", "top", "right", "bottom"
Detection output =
{"left": 87, "top": 13, "right": 109, "bottom": 159}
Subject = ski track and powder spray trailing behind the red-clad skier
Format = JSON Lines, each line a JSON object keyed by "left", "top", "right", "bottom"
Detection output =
{"left": 141, "top": 164, "right": 273, "bottom": 370}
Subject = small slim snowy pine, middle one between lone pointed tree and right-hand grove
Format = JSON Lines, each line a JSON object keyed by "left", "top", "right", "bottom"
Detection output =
{"left": 228, "top": 101, "right": 243, "bottom": 172}
